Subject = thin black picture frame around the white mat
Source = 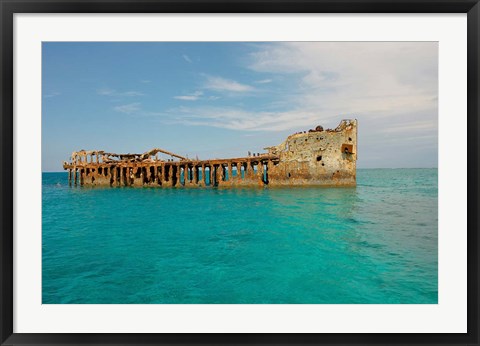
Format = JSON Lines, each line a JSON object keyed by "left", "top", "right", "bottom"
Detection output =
{"left": 0, "top": 0, "right": 480, "bottom": 345}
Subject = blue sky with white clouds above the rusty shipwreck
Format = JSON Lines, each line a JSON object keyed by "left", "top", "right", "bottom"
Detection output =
{"left": 42, "top": 42, "right": 438, "bottom": 171}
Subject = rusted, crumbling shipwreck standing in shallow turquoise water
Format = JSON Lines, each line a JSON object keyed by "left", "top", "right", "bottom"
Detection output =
{"left": 63, "top": 119, "right": 357, "bottom": 187}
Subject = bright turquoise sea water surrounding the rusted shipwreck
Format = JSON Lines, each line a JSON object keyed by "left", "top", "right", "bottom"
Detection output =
{"left": 42, "top": 169, "right": 438, "bottom": 304}
